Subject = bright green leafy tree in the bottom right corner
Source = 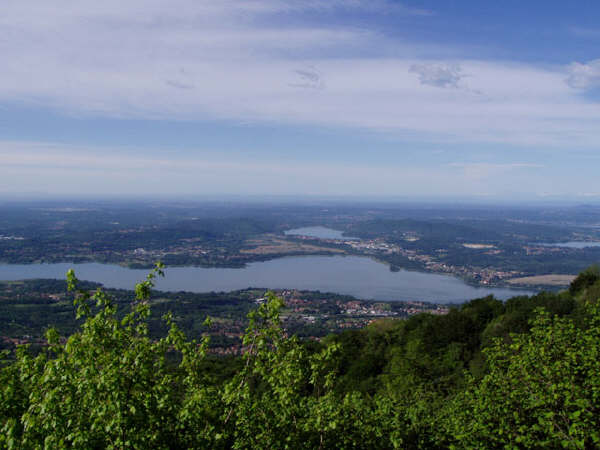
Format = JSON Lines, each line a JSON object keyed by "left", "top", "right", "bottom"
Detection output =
{"left": 447, "top": 304, "right": 600, "bottom": 449}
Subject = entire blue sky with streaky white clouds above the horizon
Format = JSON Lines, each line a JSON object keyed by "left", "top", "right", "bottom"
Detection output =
{"left": 0, "top": 0, "right": 600, "bottom": 202}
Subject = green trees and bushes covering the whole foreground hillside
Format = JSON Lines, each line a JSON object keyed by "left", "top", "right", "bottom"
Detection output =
{"left": 0, "top": 266, "right": 600, "bottom": 448}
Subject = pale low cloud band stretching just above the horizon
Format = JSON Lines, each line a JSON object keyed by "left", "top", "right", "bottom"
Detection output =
{"left": 0, "top": 141, "right": 597, "bottom": 199}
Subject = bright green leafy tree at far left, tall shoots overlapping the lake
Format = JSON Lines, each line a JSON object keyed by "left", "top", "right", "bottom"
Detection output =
{"left": 0, "top": 264, "right": 218, "bottom": 448}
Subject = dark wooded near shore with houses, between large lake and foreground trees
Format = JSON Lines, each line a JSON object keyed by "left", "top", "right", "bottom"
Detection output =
{"left": 0, "top": 279, "right": 443, "bottom": 354}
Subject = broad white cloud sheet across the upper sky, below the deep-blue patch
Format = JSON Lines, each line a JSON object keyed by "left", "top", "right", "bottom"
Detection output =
{"left": 0, "top": 0, "right": 600, "bottom": 148}
